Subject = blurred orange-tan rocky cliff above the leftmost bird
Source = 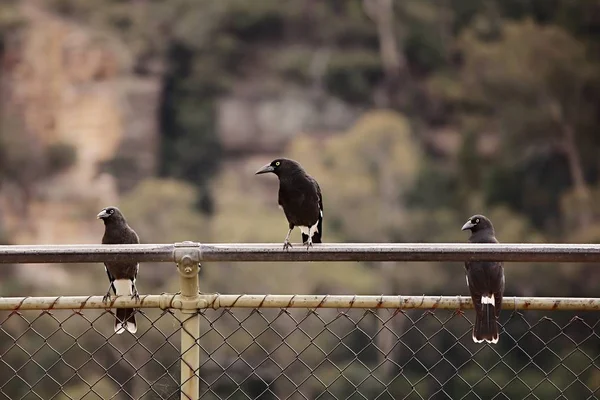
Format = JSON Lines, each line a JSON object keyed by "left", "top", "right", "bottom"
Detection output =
{"left": 0, "top": 2, "right": 160, "bottom": 244}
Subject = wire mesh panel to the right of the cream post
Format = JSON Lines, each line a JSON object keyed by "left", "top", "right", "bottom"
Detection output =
{"left": 200, "top": 309, "right": 600, "bottom": 399}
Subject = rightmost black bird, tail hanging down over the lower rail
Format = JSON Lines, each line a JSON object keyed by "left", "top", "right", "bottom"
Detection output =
{"left": 462, "top": 215, "right": 504, "bottom": 344}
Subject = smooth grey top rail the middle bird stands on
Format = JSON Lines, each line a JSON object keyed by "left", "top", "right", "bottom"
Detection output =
{"left": 0, "top": 242, "right": 600, "bottom": 264}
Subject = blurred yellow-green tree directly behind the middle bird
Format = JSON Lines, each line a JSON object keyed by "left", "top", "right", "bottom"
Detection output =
{"left": 289, "top": 111, "right": 422, "bottom": 242}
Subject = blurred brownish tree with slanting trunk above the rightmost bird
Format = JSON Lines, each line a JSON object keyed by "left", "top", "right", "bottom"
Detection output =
{"left": 459, "top": 20, "right": 598, "bottom": 231}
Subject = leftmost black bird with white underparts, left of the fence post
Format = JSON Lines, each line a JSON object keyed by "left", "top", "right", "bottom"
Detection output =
{"left": 98, "top": 207, "right": 140, "bottom": 335}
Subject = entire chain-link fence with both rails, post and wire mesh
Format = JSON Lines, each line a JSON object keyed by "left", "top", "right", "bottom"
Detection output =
{"left": 0, "top": 242, "right": 600, "bottom": 400}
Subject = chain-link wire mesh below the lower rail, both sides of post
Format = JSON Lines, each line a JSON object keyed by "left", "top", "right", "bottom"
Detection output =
{"left": 0, "top": 296, "right": 600, "bottom": 400}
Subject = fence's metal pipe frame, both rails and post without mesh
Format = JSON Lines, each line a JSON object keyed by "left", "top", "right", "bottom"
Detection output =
{"left": 0, "top": 242, "right": 600, "bottom": 400}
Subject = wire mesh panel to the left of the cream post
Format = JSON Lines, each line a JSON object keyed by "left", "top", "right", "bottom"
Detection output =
{"left": 0, "top": 310, "right": 181, "bottom": 400}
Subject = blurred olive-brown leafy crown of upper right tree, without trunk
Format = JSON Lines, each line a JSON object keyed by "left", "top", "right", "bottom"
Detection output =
{"left": 460, "top": 20, "right": 597, "bottom": 149}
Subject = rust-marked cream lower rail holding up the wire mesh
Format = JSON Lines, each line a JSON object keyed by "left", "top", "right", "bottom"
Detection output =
{"left": 0, "top": 294, "right": 600, "bottom": 311}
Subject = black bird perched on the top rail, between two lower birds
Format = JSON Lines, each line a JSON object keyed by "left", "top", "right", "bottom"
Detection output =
{"left": 256, "top": 158, "right": 323, "bottom": 250}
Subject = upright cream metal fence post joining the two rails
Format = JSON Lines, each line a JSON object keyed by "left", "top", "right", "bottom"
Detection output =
{"left": 174, "top": 242, "right": 200, "bottom": 400}
